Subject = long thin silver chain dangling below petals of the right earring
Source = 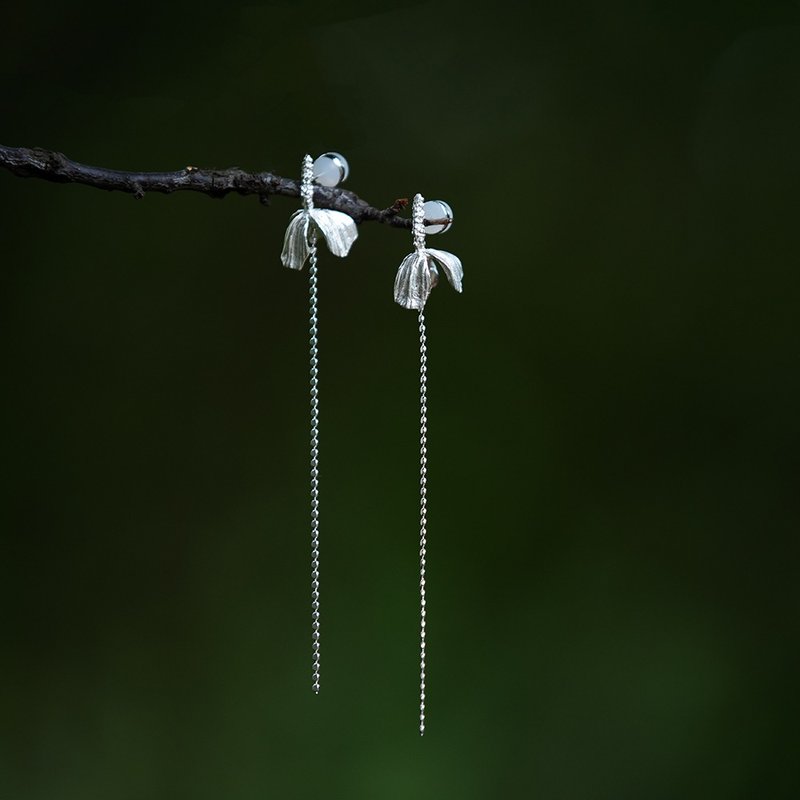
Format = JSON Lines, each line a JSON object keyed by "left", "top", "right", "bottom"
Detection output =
{"left": 419, "top": 309, "right": 428, "bottom": 736}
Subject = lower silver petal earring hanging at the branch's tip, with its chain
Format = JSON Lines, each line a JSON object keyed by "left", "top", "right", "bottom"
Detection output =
{"left": 394, "top": 194, "right": 464, "bottom": 736}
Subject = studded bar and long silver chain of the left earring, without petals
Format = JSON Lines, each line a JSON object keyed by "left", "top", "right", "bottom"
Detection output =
{"left": 300, "top": 156, "right": 320, "bottom": 694}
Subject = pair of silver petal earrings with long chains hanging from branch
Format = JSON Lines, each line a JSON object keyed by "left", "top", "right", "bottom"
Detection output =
{"left": 281, "top": 153, "right": 464, "bottom": 734}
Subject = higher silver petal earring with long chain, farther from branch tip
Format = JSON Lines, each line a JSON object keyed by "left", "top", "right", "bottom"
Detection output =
{"left": 281, "top": 153, "right": 358, "bottom": 694}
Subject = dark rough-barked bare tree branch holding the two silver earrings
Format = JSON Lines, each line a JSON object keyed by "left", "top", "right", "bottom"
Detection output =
{"left": 0, "top": 145, "right": 411, "bottom": 228}
